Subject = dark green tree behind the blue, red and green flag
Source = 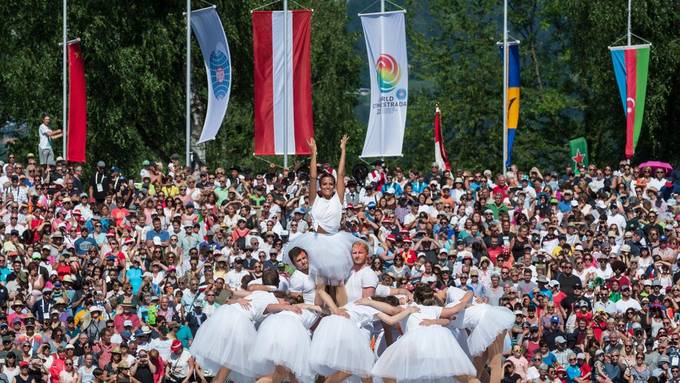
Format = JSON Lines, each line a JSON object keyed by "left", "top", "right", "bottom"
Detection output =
{"left": 555, "top": 0, "right": 680, "bottom": 164}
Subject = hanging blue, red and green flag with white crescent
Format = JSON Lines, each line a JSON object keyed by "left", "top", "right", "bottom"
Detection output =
{"left": 609, "top": 44, "right": 651, "bottom": 158}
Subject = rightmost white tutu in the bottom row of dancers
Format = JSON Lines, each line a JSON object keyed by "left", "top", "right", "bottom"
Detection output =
{"left": 463, "top": 304, "right": 515, "bottom": 357}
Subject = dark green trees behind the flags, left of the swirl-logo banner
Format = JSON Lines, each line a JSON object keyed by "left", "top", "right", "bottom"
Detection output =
{"left": 0, "top": 0, "right": 361, "bottom": 174}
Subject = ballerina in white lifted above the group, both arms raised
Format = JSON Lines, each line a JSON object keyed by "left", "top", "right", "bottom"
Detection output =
{"left": 286, "top": 135, "right": 357, "bottom": 305}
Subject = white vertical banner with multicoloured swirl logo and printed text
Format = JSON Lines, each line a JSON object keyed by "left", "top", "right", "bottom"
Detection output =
{"left": 359, "top": 11, "right": 408, "bottom": 157}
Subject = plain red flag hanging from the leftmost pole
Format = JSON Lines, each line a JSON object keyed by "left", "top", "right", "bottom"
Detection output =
{"left": 66, "top": 42, "right": 87, "bottom": 162}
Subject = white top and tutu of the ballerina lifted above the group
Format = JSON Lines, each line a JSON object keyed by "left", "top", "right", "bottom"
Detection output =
{"left": 284, "top": 193, "right": 361, "bottom": 285}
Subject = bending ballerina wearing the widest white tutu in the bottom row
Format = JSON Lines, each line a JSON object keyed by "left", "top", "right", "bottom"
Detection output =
{"left": 372, "top": 284, "right": 477, "bottom": 383}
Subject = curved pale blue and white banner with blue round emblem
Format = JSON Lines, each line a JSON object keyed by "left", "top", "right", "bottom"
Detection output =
{"left": 191, "top": 6, "right": 231, "bottom": 144}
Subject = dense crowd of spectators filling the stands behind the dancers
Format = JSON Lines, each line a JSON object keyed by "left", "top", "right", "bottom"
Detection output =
{"left": 0, "top": 154, "right": 680, "bottom": 383}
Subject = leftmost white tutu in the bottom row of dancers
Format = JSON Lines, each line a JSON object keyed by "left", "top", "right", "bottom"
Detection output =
{"left": 190, "top": 305, "right": 257, "bottom": 382}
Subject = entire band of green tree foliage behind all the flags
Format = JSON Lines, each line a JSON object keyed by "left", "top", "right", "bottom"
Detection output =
{"left": 0, "top": 0, "right": 680, "bottom": 176}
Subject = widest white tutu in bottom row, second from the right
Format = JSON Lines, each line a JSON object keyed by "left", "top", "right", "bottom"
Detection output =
{"left": 372, "top": 326, "right": 477, "bottom": 383}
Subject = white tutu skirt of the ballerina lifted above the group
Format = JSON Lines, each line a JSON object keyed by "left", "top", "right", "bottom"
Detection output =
{"left": 284, "top": 231, "right": 361, "bottom": 285}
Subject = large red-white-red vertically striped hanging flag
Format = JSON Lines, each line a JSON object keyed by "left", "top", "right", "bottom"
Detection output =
{"left": 252, "top": 10, "right": 314, "bottom": 155}
